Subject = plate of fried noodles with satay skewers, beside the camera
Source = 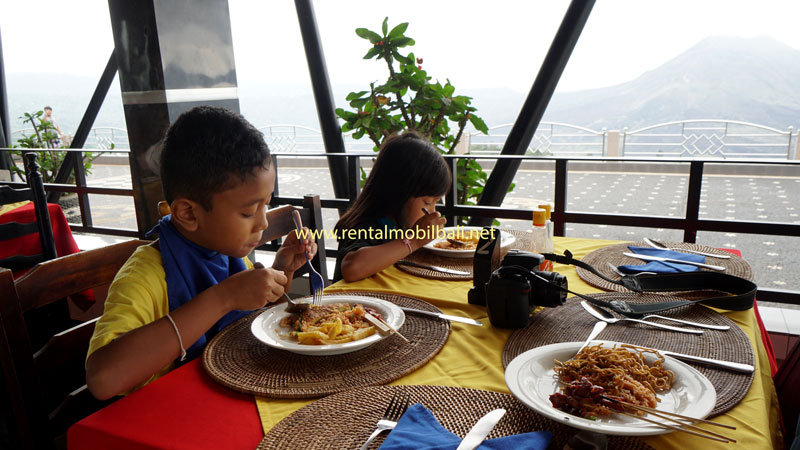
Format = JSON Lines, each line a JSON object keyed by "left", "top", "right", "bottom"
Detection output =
{"left": 505, "top": 341, "right": 717, "bottom": 436}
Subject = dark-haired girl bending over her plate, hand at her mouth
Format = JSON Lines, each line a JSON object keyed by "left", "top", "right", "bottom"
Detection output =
{"left": 333, "top": 132, "right": 452, "bottom": 281}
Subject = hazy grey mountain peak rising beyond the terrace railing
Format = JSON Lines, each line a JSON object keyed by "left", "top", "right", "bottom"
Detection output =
{"left": 543, "top": 37, "right": 800, "bottom": 130}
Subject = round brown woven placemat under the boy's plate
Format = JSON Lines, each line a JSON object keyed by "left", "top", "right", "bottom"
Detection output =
{"left": 203, "top": 292, "right": 450, "bottom": 398}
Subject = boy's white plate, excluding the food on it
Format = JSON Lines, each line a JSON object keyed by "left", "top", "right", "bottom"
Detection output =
{"left": 250, "top": 294, "right": 406, "bottom": 356}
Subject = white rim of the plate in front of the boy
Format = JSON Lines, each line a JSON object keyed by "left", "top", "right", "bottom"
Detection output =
{"left": 250, "top": 293, "right": 406, "bottom": 356}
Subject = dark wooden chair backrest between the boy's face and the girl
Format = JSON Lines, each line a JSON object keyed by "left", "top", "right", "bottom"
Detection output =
{"left": 261, "top": 195, "right": 329, "bottom": 286}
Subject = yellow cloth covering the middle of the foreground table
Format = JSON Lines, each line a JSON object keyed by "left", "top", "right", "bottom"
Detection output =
{"left": 256, "top": 237, "right": 783, "bottom": 450}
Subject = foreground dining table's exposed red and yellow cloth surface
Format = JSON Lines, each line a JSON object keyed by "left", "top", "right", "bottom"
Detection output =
{"left": 67, "top": 237, "right": 783, "bottom": 450}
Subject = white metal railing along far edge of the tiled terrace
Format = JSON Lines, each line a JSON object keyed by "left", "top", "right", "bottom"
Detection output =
{"left": 11, "top": 119, "right": 800, "bottom": 160}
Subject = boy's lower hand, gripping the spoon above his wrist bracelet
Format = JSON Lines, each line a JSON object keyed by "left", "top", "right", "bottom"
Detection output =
{"left": 218, "top": 263, "right": 287, "bottom": 311}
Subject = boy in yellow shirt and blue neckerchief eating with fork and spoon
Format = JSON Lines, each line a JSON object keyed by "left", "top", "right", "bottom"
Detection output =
{"left": 86, "top": 107, "right": 317, "bottom": 399}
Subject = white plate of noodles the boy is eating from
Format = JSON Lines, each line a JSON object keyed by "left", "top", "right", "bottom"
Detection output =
{"left": 250, "top": 294, "right": 406, "bottom": 356}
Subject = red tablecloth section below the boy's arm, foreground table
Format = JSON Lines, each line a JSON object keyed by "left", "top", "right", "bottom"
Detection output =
{"left": 67, "top": 358, "right": 264, "bottom": 450}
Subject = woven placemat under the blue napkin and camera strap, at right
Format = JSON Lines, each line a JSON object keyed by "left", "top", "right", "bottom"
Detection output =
{"left": 577, "top": 242, "right": 753, "bottom": 297}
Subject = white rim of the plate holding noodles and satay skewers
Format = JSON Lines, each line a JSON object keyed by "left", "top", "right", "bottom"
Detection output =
{"left": 504, "top": 340, "right": 717, "bottom": 436}
